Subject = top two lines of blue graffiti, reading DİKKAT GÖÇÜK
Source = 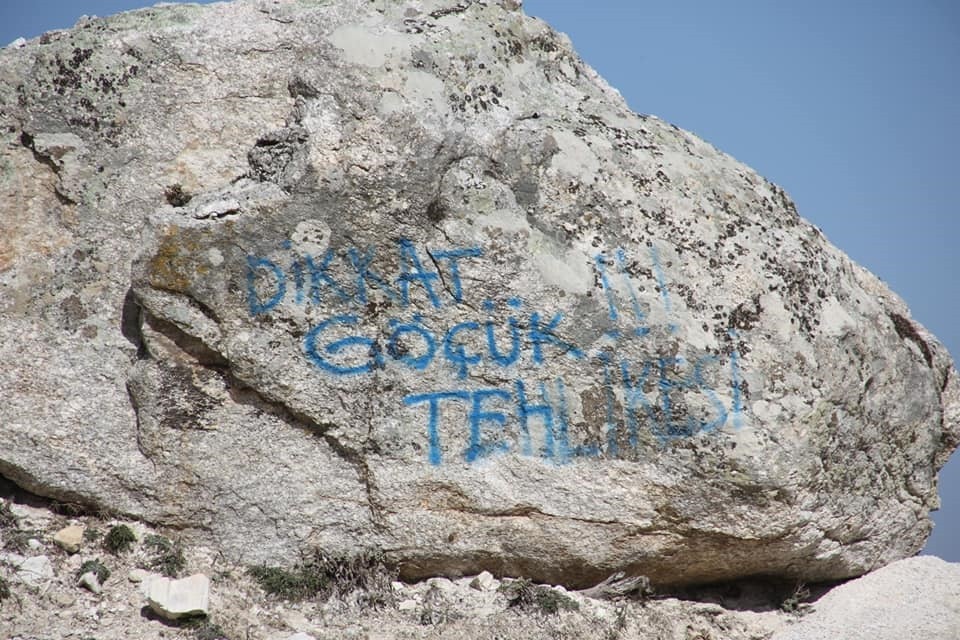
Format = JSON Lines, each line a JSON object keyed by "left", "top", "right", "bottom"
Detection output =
{"left": 247, "top": 240, "right": 583, "bottom": 379}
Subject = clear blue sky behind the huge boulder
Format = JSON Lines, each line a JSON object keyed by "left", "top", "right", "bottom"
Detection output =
{"left": 0, "top": 0, "right": 960, "bottom": 562}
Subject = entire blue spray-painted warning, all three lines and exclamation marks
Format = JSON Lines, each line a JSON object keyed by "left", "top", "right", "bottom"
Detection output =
{"left": 246, "top": 239, "right": 742, "bottom": 465}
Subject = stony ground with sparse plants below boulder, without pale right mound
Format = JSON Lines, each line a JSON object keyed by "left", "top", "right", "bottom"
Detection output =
{"left": 0, "top": 492, "right": 806, "bottom": 640}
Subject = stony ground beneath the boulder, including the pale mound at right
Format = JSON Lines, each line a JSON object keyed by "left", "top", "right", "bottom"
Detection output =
{"left": 7, "top": 485, "right": 960, "bottom": 640}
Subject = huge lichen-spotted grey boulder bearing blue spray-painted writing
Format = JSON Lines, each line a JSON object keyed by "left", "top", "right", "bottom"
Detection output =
{"left": 0, "top": 0, "right": 960, "bottom": 585}
